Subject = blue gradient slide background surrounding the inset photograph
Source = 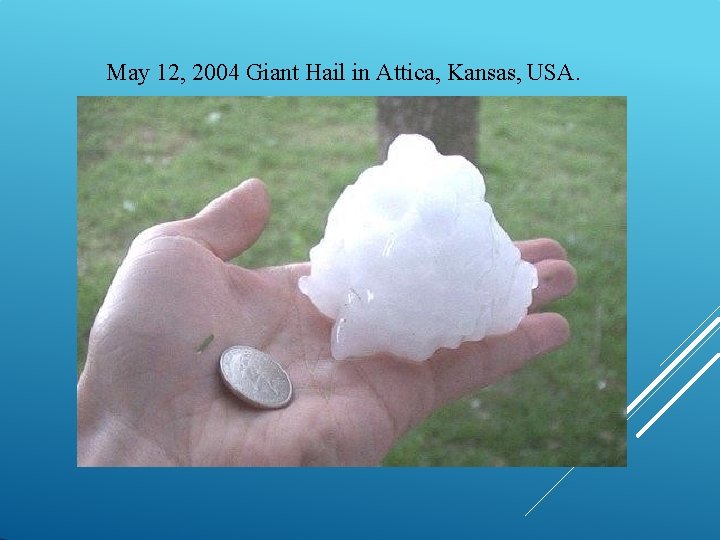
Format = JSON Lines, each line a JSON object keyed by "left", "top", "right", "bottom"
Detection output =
{"left": 0, "top": 0, "right": 720, "bottom": 540}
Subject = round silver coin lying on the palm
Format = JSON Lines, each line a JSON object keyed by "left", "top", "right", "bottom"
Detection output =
{"left": 220, "top": 345, "right": 292, "bottom": 409}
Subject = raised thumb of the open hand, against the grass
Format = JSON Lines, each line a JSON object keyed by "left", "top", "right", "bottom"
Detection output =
{"left": 181, "top": 178, "right": 270, "bottom": 261}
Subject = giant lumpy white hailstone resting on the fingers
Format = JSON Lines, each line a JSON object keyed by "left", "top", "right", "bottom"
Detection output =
{"left": 299, "top": 135, "right": 537, "bottom": 361}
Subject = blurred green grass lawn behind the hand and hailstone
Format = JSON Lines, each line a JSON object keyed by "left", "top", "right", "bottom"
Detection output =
{"left": 77, "top": 98, "right": 626, "bottom": 466}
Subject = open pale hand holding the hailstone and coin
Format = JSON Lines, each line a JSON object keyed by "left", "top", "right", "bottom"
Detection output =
{"left": 77, "top": 180, "right": 575, "bottom": 466}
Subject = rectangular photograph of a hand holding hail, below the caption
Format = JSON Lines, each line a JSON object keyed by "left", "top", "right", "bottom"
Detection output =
{"left": 77, "top": 96, "right": 627, "bottom": 467}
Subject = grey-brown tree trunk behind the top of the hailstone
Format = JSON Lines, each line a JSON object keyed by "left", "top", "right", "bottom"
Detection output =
{"left": 377, "top": 97, "right": 480, "bottom": 163}
